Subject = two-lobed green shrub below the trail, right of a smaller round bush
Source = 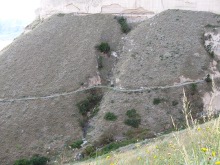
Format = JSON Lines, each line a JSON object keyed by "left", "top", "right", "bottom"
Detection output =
{"left": 124, "top": 109, "right": 141, "bottom": 128}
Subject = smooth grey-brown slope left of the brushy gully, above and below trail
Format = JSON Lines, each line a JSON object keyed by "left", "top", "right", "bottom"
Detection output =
{"left": 0, "top": 14, "right": 121, "bottom": 165}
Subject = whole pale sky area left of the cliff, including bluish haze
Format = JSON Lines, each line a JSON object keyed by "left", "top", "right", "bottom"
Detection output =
{"left": 0, "top": 0, "right": 40, "bottom": 50}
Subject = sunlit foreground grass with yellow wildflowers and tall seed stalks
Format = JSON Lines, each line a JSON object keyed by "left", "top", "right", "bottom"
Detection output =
{"left": 71, "top": 78, "right": 220, "bottom": 165}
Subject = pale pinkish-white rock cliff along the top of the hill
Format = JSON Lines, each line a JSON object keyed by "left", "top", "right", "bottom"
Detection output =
{"left": 38, "top": 0, "right": 220, "bottom": 17}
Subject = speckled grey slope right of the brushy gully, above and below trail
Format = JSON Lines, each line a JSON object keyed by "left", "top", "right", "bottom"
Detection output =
{"left": 88, "top": 10, "right": 220, "bottom": 141}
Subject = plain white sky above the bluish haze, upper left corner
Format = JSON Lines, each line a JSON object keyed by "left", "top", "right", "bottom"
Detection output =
{"left": 0, "top": 0, "right": 40, "bottom": 21}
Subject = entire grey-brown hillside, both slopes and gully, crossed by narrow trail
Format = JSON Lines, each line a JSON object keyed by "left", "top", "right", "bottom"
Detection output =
{"left": 0, "top": 10, "right": 220, "bottom": 165}
